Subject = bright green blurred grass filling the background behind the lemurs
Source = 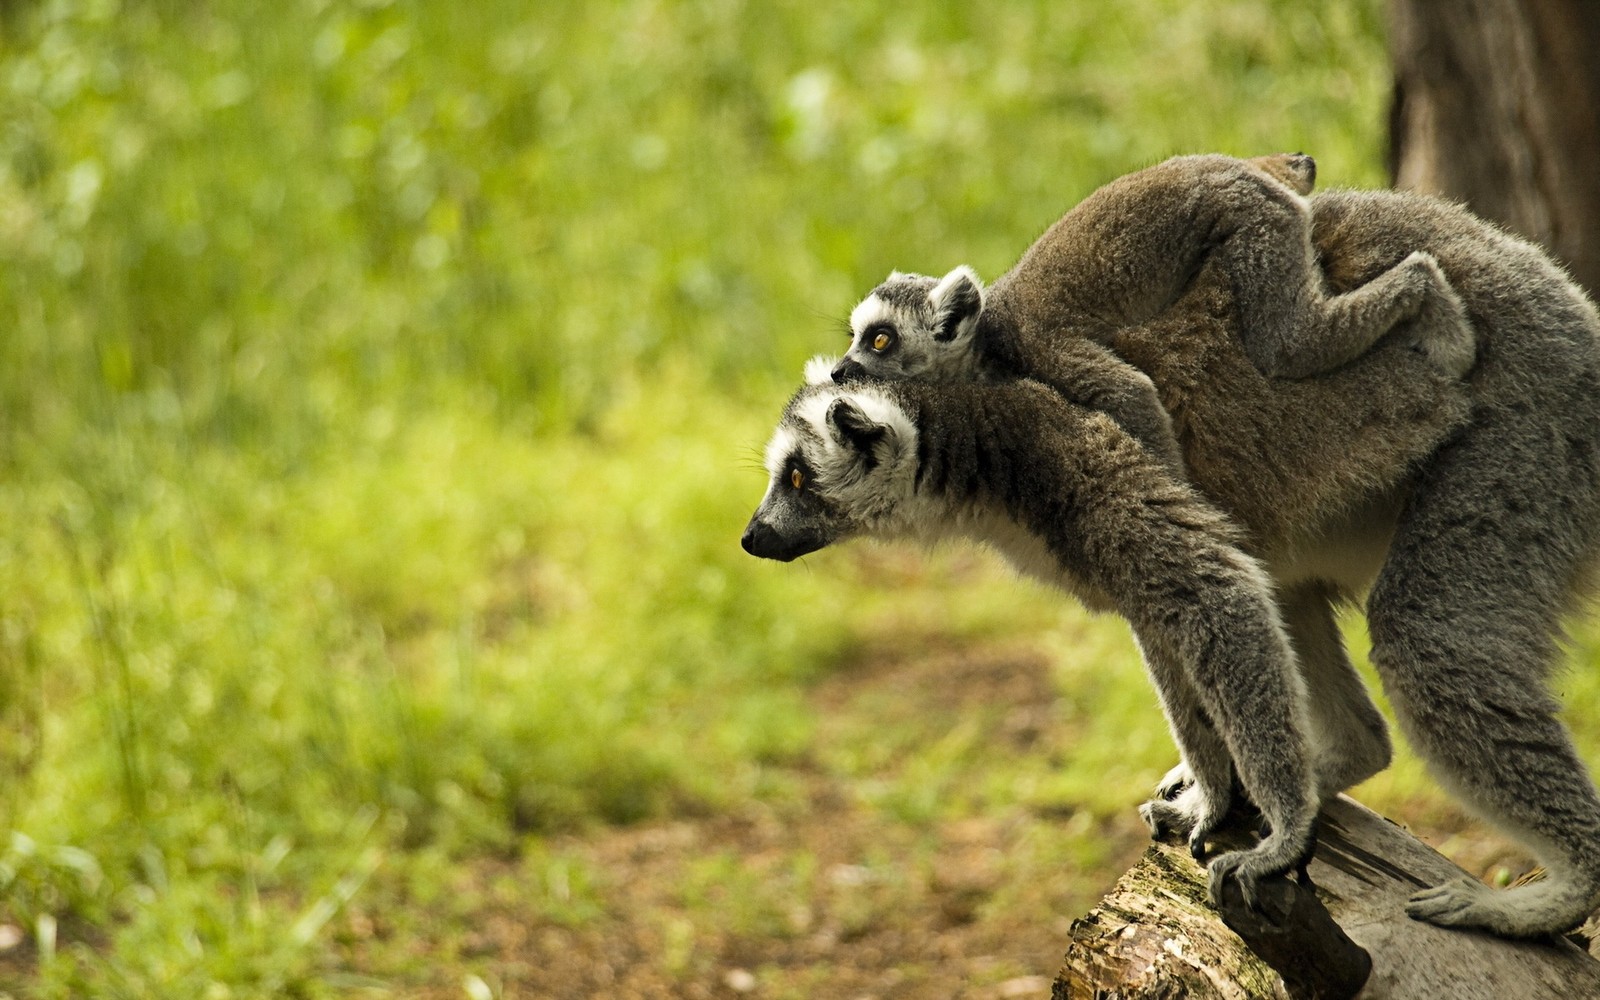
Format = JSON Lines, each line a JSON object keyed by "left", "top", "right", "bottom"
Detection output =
{"left": 0, "top": 0, "right": 1600, "bottom": 997}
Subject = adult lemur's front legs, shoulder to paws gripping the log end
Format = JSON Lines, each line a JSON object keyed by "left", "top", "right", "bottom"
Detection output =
{"left": 1013, "top": 412, "right": 1318, "bottom": 902}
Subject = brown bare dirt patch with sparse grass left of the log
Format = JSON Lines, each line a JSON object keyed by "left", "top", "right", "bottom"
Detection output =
{"left": 346, "top": 650, "right": 1144, "bottom": 1000}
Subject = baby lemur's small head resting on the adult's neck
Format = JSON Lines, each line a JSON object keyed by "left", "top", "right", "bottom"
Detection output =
{"left": 834, "top": 266, "right": 984, "bottom": 384}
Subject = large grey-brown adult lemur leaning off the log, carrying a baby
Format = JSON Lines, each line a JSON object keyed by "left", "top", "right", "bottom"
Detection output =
{"left": 744, "top": 179, "right": 1600, "bottom": 936}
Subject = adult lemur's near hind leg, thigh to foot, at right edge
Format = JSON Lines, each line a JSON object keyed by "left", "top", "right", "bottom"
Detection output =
{"left": 1368, "top": 403, "right": 1600, "bottom": 936}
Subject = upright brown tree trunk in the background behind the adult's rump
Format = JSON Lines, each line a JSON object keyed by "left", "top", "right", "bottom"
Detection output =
{"left": 1389, "top": 0, "right": 1600, "bottom": 294}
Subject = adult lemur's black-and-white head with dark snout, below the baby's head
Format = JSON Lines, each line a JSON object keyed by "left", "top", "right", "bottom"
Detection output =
{"left": 741, "top": 358, "right": 917, "bottom": 562}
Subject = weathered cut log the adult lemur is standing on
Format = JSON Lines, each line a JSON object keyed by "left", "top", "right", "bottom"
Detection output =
{"left": 1051, "top": 797, "right": 1600, "bottom": 1000}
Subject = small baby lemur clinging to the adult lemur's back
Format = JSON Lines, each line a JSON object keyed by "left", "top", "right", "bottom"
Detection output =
{"left": 834, "top": 154, "right": 1475, "bottom": 476}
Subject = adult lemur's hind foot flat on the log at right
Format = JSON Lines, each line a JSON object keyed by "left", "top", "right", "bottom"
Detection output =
{"left": 1405, "top": 877, "right": 1595, "bottom": 938}
